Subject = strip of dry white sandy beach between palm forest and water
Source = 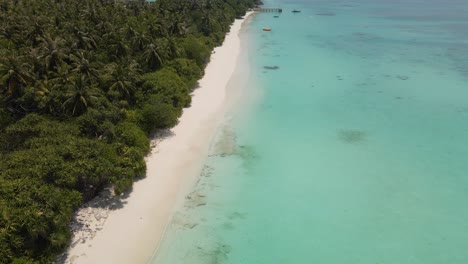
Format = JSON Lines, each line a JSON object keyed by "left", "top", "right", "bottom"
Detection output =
{"left": 63, "top": 12, "right": 252, "bottom": 264}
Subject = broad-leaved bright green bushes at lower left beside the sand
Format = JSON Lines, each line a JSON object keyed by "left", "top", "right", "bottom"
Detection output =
{"left": 0, "top": 114, "right": 149, "bottom": 258}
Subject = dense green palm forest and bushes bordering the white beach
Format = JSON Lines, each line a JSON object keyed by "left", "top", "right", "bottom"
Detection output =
{"left": 0, "top": 0, "right": 255, "bottom": 263}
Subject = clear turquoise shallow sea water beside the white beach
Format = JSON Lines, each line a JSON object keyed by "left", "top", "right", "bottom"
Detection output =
{"left": 152, "top": 0, "right": 468, "bottom": 264}
